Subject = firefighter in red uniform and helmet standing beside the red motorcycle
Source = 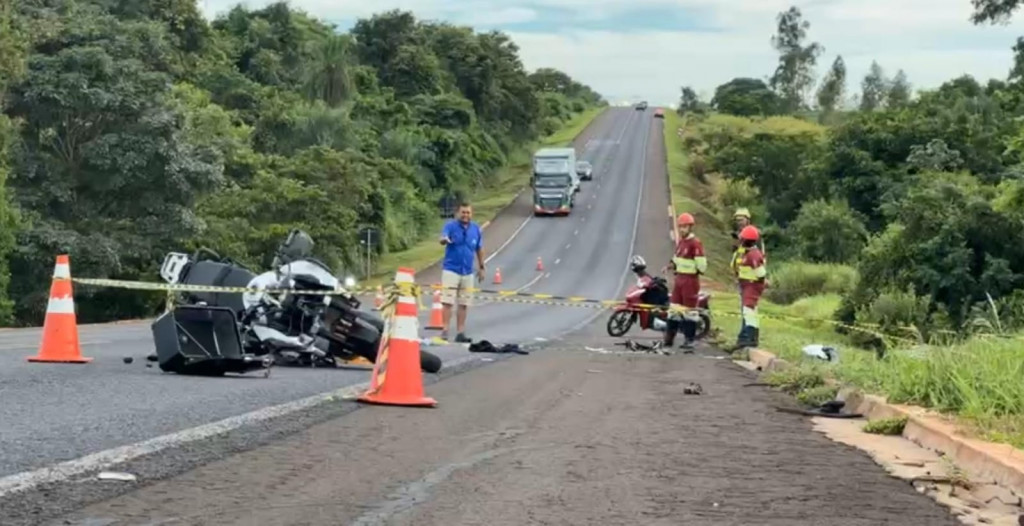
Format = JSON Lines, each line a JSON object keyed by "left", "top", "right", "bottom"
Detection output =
{"left": 665, "top": 213, "right": 708, "bottom": 349}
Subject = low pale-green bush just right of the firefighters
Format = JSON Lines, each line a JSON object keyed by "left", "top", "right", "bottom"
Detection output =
{"left": 765, "top": 262, "right": 857, "bottom": 305}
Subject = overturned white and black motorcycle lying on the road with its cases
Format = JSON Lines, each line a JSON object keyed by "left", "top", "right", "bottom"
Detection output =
{"left": 153, "top": 230, "right": 441, "bottom": 375}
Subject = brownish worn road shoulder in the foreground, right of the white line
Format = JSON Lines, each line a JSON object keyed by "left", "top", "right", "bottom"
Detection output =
{"left": 51, "top": 344, "right": 956, "bottom": 526}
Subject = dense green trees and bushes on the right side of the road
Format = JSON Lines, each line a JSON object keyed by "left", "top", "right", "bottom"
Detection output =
{"left": 681, "top": 0, "right": 1024, "bottom": 336}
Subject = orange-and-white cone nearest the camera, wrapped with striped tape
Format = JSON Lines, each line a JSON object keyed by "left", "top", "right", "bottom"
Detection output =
{"left": 358, "top": 268, "right": 437, "bottom": 407}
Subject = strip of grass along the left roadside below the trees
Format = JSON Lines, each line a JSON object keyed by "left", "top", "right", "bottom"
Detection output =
{"left": 364, "top": 107, "right": 605, "bottom": 287}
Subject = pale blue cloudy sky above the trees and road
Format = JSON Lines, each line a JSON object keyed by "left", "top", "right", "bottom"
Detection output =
{"left": 198, "top": 0, "right": 1024, "bottom": 105}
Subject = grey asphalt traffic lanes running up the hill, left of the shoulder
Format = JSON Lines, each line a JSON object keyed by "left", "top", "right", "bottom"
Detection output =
{"left": 0, "top": 108, "right": 659, "bottom": 477}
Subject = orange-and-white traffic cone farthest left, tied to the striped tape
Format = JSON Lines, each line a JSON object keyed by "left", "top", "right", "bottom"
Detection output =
{"left": 29, "top": 255, "right": 92, "bottom": 363}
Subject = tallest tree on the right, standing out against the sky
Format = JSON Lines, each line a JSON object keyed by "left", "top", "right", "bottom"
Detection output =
{"left": 770, "top": 6, "right": 824, "bottom": 112}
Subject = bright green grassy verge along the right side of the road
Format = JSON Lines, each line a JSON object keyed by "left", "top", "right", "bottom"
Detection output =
{"left": 665, "top": 109, "right": 1024, "bottom": 448}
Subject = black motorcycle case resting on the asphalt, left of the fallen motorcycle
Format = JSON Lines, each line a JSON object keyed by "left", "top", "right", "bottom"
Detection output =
{"left": 152, "top": 305, "right": 270, "bottom": 376}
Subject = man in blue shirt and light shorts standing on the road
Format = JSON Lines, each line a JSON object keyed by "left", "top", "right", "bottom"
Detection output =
{"left": 440, "top": 203, "right": 483, "bottom": 343}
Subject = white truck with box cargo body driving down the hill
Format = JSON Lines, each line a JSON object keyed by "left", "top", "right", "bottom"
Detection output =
{"left": 530, "top": 148, "right": 580, "bottom": 216}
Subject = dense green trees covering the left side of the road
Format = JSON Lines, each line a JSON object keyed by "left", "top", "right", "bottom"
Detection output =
{"left": 0, "top": 0, "right": 603, "bottom": 323}
